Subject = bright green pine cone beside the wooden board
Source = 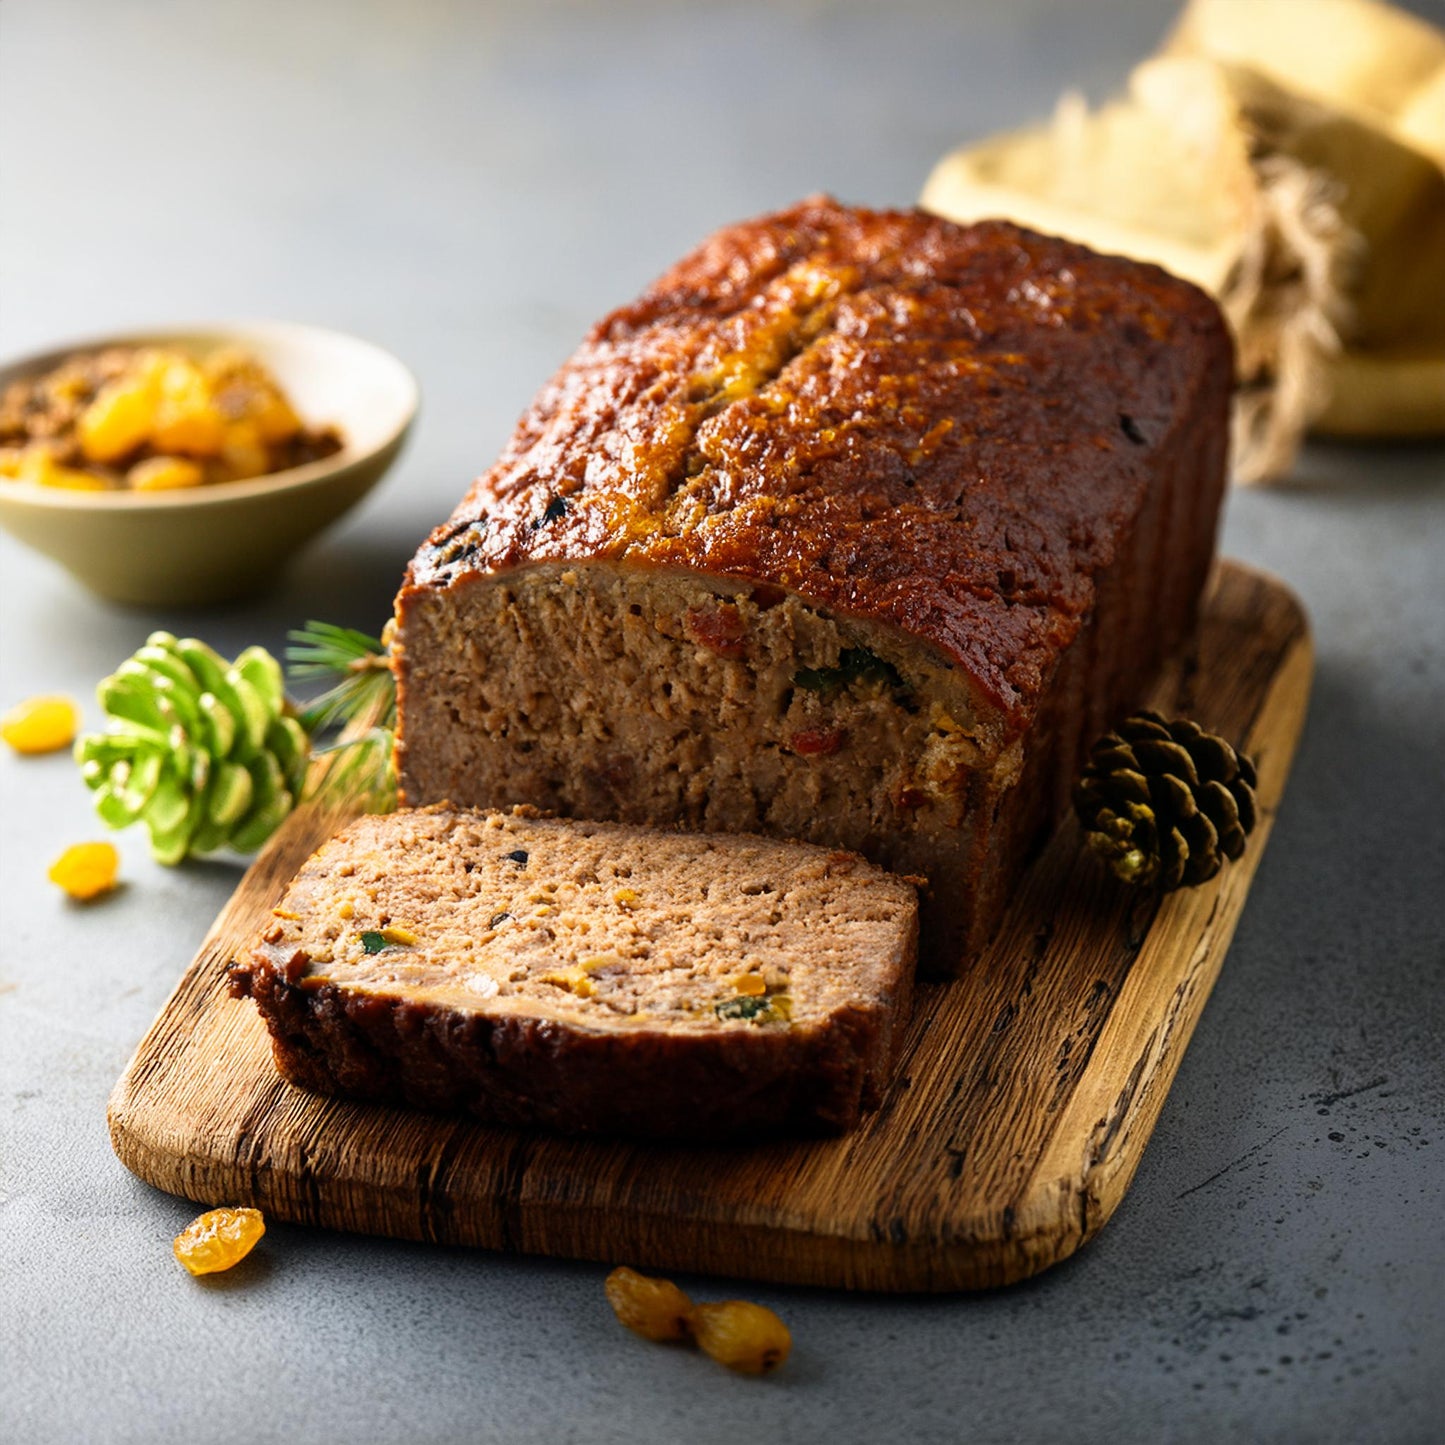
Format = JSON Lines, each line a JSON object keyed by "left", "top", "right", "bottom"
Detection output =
{"left": 75, "top": 631, "right": 311, "bottom": 863}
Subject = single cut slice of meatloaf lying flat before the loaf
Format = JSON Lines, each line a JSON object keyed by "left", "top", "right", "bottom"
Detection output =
{"left": 233, "top": 806, "right": 918, "bottom": 1140}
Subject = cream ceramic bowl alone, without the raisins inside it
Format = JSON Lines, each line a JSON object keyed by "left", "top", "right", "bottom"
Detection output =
{"left": 0, "top": 321, "right": 418, "bottom": 607}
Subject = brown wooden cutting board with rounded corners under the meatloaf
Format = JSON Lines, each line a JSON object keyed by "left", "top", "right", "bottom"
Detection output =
{"left": 110, "top": 562, "right": 1312, "bottom": 1290}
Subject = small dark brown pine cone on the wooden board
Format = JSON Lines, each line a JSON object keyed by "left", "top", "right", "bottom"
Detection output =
{"left": 1074, "top": 712, "right": 1256, "bottom": 893}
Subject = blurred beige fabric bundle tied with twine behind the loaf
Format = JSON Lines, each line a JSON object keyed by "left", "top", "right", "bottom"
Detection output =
{"left": 922, "top": 0, "right": 1445, "bottom": 481}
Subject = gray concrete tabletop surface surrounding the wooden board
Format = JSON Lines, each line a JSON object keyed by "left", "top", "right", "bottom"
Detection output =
{"left": 0, "top": 0, "right": 1445, "bottom": 1445}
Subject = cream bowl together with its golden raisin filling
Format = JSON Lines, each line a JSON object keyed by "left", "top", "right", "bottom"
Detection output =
{"left": 0, "top": 322, "right": 418, "bottom": 607}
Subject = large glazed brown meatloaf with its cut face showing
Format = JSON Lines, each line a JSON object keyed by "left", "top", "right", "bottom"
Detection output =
{"left": 394, "top": 199, "right": 1233, "bottom": 971}
